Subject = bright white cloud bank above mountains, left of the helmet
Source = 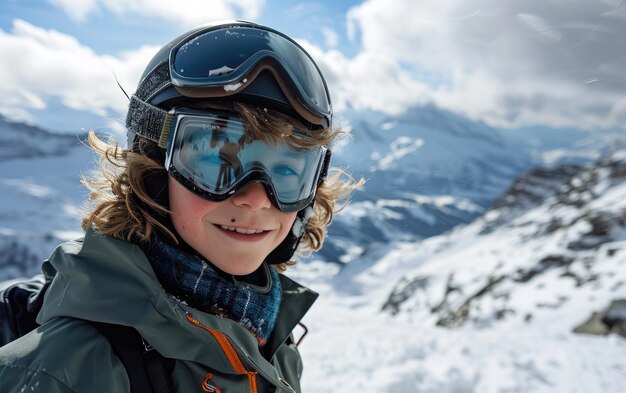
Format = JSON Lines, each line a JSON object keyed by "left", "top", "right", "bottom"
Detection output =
{"left": 0, "top": 19, "right": 159, "bottom": 120}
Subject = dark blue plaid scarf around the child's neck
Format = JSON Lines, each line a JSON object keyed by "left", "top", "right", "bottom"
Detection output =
{"left": 142, "top": 238, "right": 281, "bottom": 345}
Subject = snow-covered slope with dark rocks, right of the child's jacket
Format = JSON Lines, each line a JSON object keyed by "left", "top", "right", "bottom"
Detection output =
{"left": 290, "top": 150, "right": 626, "bottom": 393}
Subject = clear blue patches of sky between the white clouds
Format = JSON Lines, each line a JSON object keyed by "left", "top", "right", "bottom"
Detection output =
{"left": 0, "top": 0, "right": 359, "bottom": 54}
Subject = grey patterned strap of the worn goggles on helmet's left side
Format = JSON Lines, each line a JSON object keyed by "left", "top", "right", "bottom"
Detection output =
{"left": 126, "top": 95, "right": 174, "bottom": 148}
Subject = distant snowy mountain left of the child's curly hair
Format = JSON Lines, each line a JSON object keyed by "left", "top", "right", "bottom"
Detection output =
{"left": 0, "top": 118, "right": 93, "bottom": 279}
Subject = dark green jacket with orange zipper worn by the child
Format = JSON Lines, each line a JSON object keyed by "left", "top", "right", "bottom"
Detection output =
{"left": 0, "top": 230, "right": 317, "bottom": 393}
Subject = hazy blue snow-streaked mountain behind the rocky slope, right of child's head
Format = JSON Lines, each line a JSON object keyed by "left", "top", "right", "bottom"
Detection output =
{"left": 322, "top": 106, "right": 606, "bottom": 262}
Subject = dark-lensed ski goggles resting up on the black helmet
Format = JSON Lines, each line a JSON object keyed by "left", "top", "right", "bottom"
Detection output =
{"left": 162, "top": 24, "right": 332, "bottom": 128}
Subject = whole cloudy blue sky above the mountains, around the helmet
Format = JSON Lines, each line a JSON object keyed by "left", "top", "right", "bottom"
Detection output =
{"left": 0, "top": 0, "right": 626, "bottom": 132}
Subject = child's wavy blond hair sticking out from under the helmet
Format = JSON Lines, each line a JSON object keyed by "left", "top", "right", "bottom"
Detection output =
{"left": 81, "top": 103, "right": 363, "bottom": 271}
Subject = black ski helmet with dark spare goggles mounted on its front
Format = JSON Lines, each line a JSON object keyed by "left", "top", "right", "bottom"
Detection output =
{"left": 126, "top": 21, "right": 332, "bottom": 147}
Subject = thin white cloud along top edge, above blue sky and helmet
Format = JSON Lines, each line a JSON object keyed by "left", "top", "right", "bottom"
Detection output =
{"left": 48, "top": 0, "right": 265, "bottom": 28}
